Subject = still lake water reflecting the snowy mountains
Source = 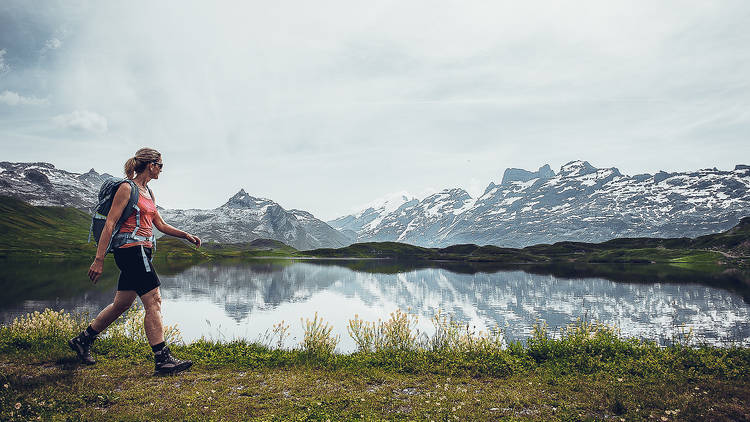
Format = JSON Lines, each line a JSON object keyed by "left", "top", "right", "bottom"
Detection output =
{"left": 0, "top": 260, "right": 750, "bottom": 352}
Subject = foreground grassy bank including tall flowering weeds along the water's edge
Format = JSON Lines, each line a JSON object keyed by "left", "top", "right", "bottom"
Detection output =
{"left": 0, "top": 309, "right": 750, "bottom": 421}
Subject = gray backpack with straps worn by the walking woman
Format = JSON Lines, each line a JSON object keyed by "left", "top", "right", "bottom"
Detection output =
{"left": 88, "top": 177, "right": 156, "bottom": 254}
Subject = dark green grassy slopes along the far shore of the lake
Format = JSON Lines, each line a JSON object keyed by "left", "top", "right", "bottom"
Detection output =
{"left": 0, "top": 196, "right": 750, "bottom": 272}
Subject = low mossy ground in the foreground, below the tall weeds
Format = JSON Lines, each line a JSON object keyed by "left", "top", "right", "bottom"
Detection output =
{"left": 0, "top": 348, "right": 750, "bottom": 421}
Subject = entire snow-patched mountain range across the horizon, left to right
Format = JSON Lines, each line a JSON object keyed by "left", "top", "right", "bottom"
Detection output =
{"left": 0, "top": 160, "right": 750, "bottom": 250}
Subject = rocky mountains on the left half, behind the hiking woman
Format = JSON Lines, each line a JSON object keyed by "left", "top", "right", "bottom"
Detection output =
{"left": 0, "top": 162, "right": 351, "bottom": 249}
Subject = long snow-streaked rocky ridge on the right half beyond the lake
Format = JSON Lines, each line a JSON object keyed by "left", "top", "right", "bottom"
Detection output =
{"left": 332, "top": 160, "right": 750, "bottom": 247}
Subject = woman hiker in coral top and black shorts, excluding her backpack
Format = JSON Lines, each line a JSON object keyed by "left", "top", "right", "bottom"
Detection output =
{"left": 68, "top": 148, "right": 201, "bottom": 374}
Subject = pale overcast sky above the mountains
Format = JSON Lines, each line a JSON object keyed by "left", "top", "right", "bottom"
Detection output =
{"left": 0, "top": 0, "right": 750, "bottom": 220}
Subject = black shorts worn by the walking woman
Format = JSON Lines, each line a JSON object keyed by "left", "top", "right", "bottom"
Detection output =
{"left": 114, "top": 246, "right": 161, "bottom": 296}
